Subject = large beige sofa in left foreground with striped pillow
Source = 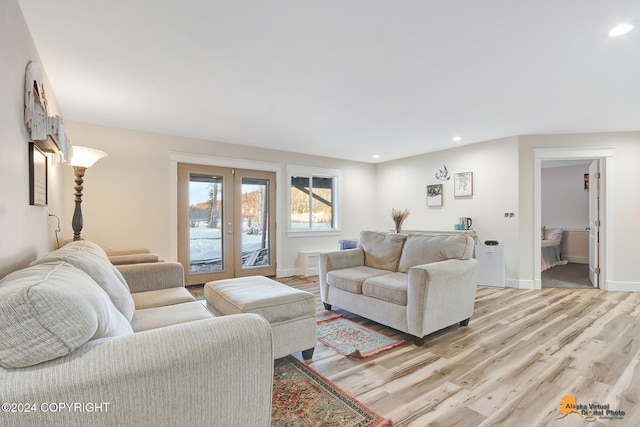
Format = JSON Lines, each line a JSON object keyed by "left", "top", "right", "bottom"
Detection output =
{"left": 0, "top": 241, "right": 273, "bottom": 426}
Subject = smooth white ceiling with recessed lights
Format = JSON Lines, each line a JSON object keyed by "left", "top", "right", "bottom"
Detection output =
{"left": 18, "top": 0, "right": 640, "bottom": 163}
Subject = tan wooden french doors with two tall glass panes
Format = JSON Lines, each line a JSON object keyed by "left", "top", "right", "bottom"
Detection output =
{"left": 178, "top": 163, "right": 276, "bottom": 285}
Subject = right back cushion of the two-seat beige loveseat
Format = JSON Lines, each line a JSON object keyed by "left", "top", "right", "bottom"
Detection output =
{"left": 398, "top": 234, "right": 474, "bottom": 273}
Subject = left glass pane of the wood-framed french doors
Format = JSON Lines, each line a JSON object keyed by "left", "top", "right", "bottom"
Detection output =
{"left": 189, "top": 174, "right": 224, "bottom": 274}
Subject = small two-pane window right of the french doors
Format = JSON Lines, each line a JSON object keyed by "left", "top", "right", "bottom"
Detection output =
{"left": 288, "top": 167, "right": 338, "bottom": 233}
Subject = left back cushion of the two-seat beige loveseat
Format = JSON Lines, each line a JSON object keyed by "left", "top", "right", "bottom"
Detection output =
{"left": 358, "top": 231, "right": 406, "bottom": 271}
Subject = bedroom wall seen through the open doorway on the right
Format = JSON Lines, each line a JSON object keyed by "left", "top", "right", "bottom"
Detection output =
{"left": 541, "top": 164, "right": 589, "bottom": 230}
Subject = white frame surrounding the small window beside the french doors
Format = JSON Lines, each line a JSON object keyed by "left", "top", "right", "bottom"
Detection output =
{"left": 287, "top": 165, "right": 342, "bottom": 237}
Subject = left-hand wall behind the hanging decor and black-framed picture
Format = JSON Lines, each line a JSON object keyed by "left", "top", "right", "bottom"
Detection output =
{"left": 0, "top": 0, "right": 62, "bottom": 277}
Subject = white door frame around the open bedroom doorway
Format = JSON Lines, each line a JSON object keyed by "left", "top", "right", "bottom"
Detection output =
{"left": 533, "top": 147, "right": 615, "bottom": 291}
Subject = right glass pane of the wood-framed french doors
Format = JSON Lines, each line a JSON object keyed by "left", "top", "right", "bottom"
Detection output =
{"left": 242, "top": 177, "right": 271, "bottom": 269}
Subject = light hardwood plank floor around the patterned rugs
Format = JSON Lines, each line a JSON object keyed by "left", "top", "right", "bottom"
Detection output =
{"left": 292, "top": 283, "right": 640, "bottom": 427}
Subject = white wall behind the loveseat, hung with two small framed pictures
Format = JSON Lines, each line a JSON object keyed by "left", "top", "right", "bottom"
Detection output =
{"left": 375, "top": 138, "right": 519, "bottom": 281}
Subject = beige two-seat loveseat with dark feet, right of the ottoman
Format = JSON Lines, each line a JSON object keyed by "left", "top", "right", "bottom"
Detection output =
{"left": 319, "top": 231, "right": 478, "bottom": 345}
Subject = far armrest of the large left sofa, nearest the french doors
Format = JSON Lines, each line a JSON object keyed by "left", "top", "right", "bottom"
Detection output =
{"left": 116, "top": 262, "right": 184, "bottom": 292}
